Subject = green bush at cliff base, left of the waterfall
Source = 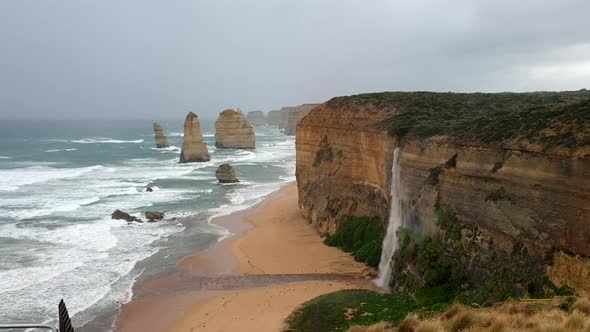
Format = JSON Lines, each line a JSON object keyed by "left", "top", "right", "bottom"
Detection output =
{"left": 324, "top": 217, "right": 383, "bottom": 267}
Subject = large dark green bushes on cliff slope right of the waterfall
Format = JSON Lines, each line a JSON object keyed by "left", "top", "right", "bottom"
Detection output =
{"left": 391, "top": 209, "right": 562, "bottom": 305}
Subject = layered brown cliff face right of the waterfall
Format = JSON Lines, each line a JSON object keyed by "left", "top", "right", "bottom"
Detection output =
{"left": 400, "top": 140, "right": 590, "bottom": 255}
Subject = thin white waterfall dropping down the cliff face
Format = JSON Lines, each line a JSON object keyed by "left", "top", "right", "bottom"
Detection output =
{"left": 375, "top": 148, "right": 403, "bottom": 290}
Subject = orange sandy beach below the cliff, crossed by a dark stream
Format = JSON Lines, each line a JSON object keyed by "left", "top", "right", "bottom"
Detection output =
{"left": 117, "top": 183, "right": 375, "bottom": 332}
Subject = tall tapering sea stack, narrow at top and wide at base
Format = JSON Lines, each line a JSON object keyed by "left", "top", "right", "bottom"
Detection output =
{"left": 180, "top": 112, "right": 211, "bottom": 163}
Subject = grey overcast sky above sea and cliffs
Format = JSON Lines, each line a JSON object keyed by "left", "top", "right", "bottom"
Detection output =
{"left": 0, "top": 0, "right": 590, "bottom": 118}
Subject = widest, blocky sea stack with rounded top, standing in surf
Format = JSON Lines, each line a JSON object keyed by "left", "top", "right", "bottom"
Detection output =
{"left": 215, "top": 109, "right": 256, "bottom": 149}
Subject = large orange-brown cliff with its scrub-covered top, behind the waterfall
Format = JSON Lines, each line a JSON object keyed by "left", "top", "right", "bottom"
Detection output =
{"left": 297, "top": 90, "right": 590, "bottom": 294}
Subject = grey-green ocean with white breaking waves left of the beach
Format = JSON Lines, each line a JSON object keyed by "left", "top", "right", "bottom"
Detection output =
{"left": 0, "top": 119, "right": 295, "bottom": 331}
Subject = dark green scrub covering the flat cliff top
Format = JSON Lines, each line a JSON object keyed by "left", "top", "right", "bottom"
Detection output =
{"left": 328, "top": 89, "right": 590, "bottom": 149}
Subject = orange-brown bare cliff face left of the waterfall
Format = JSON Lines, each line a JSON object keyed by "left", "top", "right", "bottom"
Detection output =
{"left": 296, "top": 104, "right": 393, "bottom": 233}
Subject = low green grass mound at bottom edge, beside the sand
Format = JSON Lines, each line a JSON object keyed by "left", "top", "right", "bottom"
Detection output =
{"left": 285, "top": 290, "right": 418, "bottom": 332}
